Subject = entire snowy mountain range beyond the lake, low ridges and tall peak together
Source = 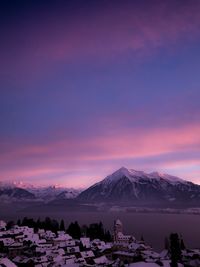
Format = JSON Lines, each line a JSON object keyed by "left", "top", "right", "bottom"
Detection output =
{"left": 0, "top": 167, "right": 200, "bottom": 207}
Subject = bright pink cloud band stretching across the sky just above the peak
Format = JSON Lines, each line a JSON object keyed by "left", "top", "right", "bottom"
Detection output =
{"left": 1, "top": 125, "right": 200, "bottom": 160}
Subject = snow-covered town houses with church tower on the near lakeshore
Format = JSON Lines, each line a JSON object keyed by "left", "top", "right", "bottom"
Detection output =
{"left": 0, "top": 220, "right": 200, "bottom": 267}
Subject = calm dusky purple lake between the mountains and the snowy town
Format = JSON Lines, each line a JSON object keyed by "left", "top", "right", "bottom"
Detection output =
{"left": 0, "top": 210, "right": 200, "bottom": 251}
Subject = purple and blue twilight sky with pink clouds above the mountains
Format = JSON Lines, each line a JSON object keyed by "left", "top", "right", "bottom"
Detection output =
{"left": 0, "top": 0, "right": 200, "bottom": 187}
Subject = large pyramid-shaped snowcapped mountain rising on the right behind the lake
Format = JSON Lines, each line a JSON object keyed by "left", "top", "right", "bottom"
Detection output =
{"left": 78, "top": 167, "right": 200, "bottom": 205}
